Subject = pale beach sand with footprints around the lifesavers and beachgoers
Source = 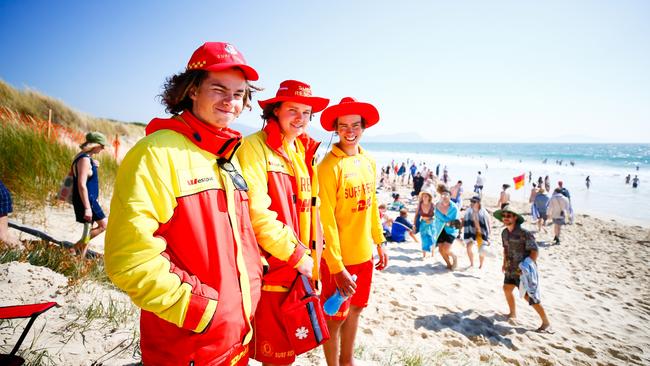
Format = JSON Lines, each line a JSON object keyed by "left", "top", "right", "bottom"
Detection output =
{"left": 0, "top": 188, "right": 650, "bottom": 365}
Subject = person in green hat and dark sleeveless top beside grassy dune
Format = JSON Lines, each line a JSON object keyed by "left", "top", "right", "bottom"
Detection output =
{"left": 72, "top": 131, "right": 108, "bottom": 258}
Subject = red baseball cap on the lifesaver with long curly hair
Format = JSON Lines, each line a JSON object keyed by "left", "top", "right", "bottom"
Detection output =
{"left": 187, "top": 42, "right": 259, "bottom": 81}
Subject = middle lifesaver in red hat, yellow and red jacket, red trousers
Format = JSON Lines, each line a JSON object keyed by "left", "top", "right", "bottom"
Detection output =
{"left": 237, "top": 80, "right": 329, "bottom": 364}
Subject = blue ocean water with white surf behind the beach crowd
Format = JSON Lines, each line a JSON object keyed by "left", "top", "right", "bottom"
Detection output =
{"left": 362, "top": 143, "right": 650, "bottom": 228}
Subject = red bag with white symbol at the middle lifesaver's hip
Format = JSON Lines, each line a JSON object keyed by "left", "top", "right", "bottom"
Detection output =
{"left": 280, "top": 274, "right": 330, "bottom": 356}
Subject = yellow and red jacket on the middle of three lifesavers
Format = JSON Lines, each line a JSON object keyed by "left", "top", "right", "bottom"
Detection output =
{"left": 237, "top": 120, "right": 323, "bottom": 291}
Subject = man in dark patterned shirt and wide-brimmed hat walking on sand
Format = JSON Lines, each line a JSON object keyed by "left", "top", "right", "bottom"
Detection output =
{"left": 494, "top": 205, "right": 550, "bottom": 332}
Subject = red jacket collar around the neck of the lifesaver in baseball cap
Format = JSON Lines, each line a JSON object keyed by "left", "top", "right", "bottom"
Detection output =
{"left": 145, "top": 110, "right": 241, "bottom": 159}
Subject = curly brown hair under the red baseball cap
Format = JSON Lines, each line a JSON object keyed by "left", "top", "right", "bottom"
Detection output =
{"left": 158, "top": 70, "right": 263, "bottom": 115}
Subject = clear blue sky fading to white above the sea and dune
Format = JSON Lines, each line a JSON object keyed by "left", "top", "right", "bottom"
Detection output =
{"left": 0, "top": 0, "right": 650, "bottom": 143}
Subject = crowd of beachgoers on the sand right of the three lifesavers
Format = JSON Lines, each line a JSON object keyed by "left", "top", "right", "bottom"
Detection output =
{"left": 379, "top": 160, "right": 573, "bottom": 332}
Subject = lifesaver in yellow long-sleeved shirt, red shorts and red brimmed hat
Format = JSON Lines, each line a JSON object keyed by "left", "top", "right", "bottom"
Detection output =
{"left": 318, "top": 97, "right": 388, "bottom": 365}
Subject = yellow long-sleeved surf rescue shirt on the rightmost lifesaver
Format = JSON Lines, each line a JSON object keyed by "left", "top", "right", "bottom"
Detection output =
{"left": 318, "top": 145, "right": 386, "bottom": 274}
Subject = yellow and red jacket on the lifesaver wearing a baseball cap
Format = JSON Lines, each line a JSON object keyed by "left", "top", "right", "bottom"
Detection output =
{"left": 104, "top": 111, "right": 262, "bottom": 365}
